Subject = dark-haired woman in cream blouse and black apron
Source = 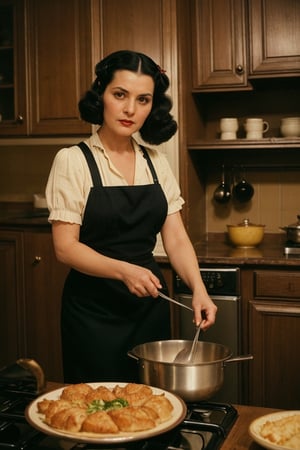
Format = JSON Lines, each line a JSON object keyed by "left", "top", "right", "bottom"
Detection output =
{"left": 46, "top": 51, "right": 216, "bottom": 383}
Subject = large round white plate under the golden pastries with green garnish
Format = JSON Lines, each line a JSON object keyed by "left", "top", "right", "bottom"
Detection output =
{"left": 25, "top": 382, "right": 187, "bottom": 444}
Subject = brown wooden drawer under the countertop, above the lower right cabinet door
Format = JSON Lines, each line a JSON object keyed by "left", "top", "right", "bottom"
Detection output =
{"left": 254, "top": 270, "right": 300, "bottom": 300}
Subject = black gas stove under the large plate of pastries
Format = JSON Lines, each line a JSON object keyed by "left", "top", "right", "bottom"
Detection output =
{"left": 0, "top": 362, "right": 237, "bottom": 450}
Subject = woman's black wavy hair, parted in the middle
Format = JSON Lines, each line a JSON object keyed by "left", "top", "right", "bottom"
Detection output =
{"left": 78, "top": 50, "right": 177, "bottom": 145}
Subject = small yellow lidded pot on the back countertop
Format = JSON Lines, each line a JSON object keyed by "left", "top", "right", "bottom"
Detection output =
{"left": 227, "top": 220, "right": 265, "bottom": 247}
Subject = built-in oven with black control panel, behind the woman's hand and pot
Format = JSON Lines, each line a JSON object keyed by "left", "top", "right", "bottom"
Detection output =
{"left": 175, "top": 267, "right": 241, "bottom": 403}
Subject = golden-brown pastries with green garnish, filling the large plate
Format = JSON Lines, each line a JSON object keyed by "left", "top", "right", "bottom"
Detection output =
{"left": 37, "top": 383, "right": 173, "bottom": 434}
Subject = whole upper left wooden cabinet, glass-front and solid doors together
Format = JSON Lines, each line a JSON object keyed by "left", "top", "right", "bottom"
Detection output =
{"left": 0, "top": 0, "right": 93, "bottom": 136}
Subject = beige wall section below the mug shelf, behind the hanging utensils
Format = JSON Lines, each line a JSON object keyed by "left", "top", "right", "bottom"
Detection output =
{"left": 206, "top": 169, "right": 300, "bottom": 233}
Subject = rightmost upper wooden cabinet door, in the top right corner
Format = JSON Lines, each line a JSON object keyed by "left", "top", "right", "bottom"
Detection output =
{"left": 249, "top": 0, "right": 300, "bottom": 76}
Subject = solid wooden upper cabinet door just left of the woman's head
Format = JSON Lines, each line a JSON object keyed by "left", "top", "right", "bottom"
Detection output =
{"left": 27, "top": 0, "right": 93, "bottom": 135}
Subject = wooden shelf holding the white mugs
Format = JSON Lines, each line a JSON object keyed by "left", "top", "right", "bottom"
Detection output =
{"left": 187, "top": 138, "right": 300, "bottom": 150}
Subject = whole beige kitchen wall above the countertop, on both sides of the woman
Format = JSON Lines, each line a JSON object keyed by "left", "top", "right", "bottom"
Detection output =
{"left": 0, "top": 141, "right": 300, "bottom": 233}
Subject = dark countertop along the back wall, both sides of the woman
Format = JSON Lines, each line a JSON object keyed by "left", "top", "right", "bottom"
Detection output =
{"left": 0, "top": 208, "right": 300, "bottom": 268}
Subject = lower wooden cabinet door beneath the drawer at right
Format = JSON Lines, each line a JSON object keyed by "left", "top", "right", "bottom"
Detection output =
{"left": 249, "top": 301, "right": 300, "bottom": 409}
